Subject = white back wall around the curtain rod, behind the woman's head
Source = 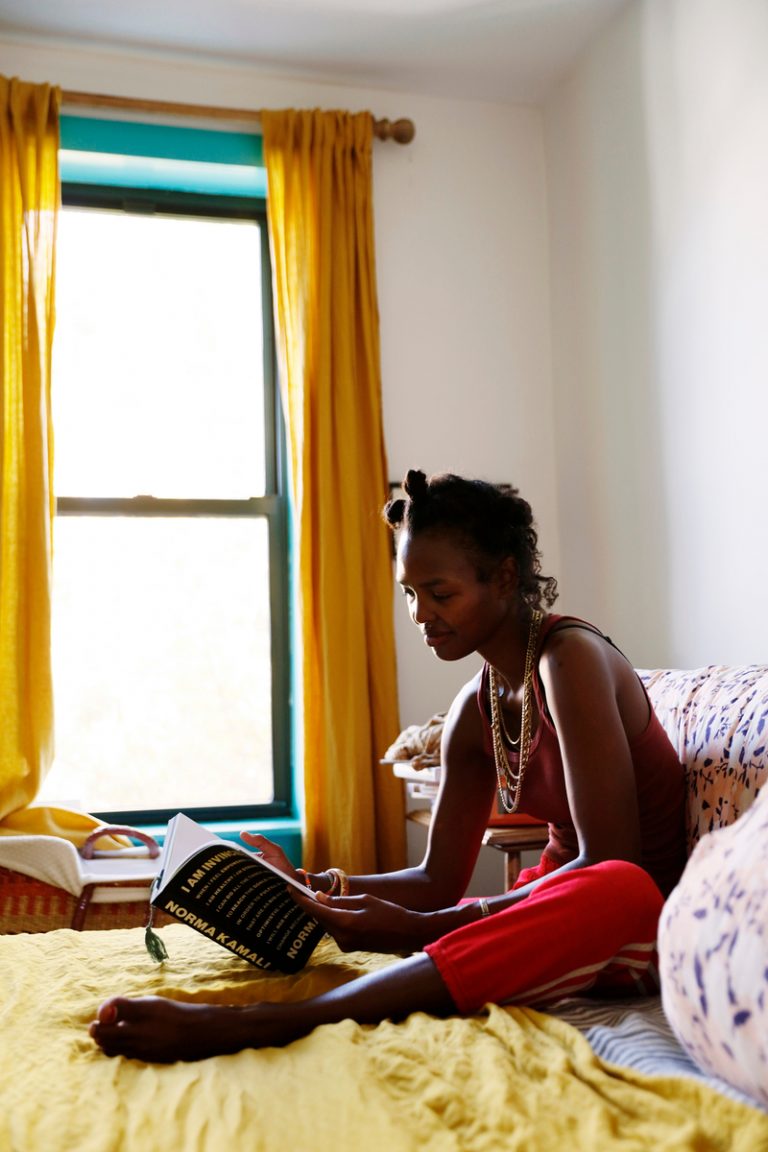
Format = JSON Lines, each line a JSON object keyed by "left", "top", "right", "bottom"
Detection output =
{"left": 0, "top": 39, "right": 557, "bottom": 723}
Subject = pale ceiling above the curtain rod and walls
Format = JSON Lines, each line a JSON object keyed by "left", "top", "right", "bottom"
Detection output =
{"left": 0, "top": 0, "right": 631, "bottom": 104}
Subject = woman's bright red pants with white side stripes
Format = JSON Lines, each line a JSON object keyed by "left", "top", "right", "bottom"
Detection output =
{"left": 425, "top": 856, "right": 664, "bottom": 1015}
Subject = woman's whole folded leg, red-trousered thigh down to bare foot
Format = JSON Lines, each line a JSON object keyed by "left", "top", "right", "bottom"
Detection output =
{"left": 91, "top": 861, "right": 663, "bottom": 1061}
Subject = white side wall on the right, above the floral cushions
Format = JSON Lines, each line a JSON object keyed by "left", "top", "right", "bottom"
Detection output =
{"left": 545, "top": 0, "right": 768, "bottom": 666}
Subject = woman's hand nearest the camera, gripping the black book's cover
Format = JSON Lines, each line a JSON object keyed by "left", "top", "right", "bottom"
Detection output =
{"left": 290, "top": 888, "right": 439, "bottom": 953}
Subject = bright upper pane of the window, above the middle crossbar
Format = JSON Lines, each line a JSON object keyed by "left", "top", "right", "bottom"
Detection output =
{"left": 53, "top": 209, "right": 265, "bottom": 499}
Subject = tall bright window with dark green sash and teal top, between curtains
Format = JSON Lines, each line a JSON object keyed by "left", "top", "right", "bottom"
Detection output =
{"left": 41, "top": 118, "right": 292, "bottom": 823}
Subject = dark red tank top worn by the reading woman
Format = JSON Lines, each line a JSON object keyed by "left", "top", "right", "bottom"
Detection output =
{"left": 478, "top": 615, "right": 685, "bottom": 895}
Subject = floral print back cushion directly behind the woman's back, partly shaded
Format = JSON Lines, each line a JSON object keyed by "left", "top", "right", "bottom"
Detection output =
{"left": 639, "top": 665, "right": 768, "bottom": 854}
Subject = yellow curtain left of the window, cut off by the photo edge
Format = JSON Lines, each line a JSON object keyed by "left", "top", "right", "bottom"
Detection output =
{"left": 0, "top": 76, "right": 113, "bottom": 843}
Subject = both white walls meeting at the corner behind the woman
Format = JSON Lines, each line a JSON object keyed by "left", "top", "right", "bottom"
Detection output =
{"left": 7, "top": 0, "right": 768, "bottom": 686}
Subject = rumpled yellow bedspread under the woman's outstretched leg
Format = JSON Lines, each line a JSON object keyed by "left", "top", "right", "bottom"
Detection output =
{"left": 0, "top": 925, "right": 768, "bottom": 1152}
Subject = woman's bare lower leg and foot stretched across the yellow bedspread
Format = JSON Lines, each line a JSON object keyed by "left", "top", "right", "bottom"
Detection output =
{"left": 90, "top": 953, "right": 456, "bottom": 1063}
